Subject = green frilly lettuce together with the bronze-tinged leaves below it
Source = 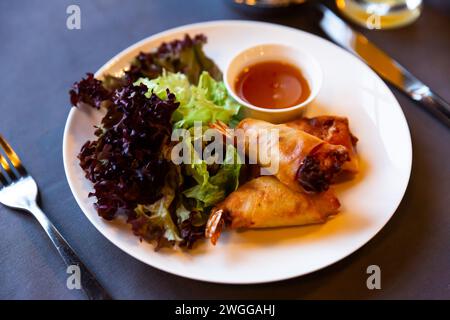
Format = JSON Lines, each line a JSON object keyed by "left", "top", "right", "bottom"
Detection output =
{"left": 130, "top": 71, "right": 242, "bottom": 247}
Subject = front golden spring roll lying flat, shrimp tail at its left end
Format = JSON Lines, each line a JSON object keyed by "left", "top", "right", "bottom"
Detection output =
{"left": 205, "top": 176, "right": 340, "bottom": 244}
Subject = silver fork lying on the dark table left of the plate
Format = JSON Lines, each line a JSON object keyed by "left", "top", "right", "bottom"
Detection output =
{"left": 0, "top": 135, "right": 111, "bottom": 300}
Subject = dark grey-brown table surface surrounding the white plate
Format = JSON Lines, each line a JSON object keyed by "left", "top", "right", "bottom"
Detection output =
{"left": 0, "top": 0, "right": 450, "bottom": 299}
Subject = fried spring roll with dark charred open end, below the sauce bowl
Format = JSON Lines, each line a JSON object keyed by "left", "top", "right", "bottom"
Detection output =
{"left": 223, "top": 118, "right": 348, "bottom": 192}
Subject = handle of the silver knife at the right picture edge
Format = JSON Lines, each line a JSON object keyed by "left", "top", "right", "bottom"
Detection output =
{"left": 409, "top": 86, "right": 450, "bottom": 128}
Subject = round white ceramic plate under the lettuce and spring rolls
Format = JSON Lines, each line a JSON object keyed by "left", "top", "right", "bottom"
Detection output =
{"left": 63, "top": 21, "right": 412, "bottom": 283}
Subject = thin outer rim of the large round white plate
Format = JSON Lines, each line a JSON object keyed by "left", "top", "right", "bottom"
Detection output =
{"left": 62, "top": 19, "right": 413, "bottom": 285}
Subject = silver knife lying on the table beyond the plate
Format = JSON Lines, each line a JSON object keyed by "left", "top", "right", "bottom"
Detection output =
{"left": 318, "top": 4, "right": 450, "bottom": 127}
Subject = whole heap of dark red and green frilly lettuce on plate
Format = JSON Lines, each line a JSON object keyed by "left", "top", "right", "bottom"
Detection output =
{"left": 69, "top": 34, "right": 242, "bottom": 249}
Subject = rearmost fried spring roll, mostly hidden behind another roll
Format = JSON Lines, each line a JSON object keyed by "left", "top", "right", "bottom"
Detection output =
{"left": 286, "top": 116, "right": 359, "bottom": 177}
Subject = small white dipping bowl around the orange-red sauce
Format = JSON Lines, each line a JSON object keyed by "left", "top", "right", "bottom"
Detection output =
{"left": 225, "top": 44, "right": 322, "bottom": 123}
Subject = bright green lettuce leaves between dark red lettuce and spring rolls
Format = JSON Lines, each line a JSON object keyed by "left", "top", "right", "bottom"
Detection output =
{"left": 134, "top": 71, "right": 242, "bottom": 248}
